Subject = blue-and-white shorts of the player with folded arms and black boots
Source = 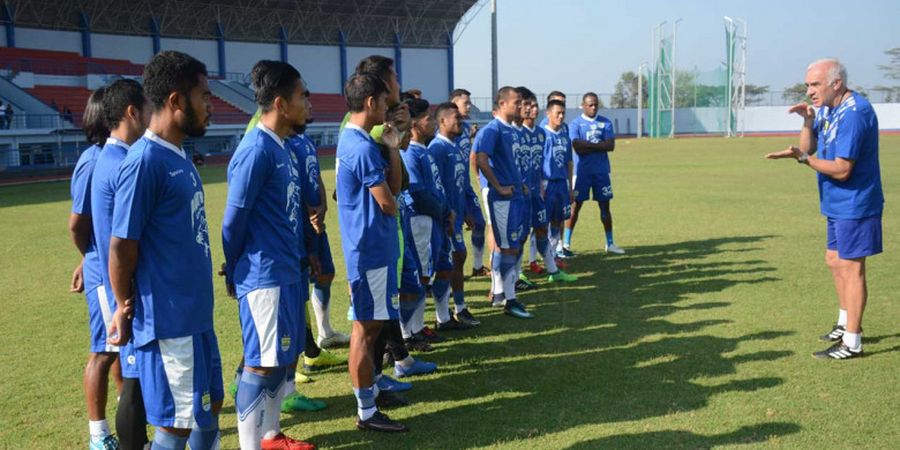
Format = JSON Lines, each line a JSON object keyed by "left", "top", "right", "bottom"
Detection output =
{"left": 348, "top": 263, "right": 400, "bottom": 320}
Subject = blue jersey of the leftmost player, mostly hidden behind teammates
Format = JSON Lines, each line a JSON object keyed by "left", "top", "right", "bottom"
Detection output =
{"left": 70, "top": 145, "right": 102, "bottom": 292}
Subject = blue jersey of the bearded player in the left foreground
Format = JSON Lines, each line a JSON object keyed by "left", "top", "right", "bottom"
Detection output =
{"left": 112, "top": 130, "right": 213, "bottom": 347}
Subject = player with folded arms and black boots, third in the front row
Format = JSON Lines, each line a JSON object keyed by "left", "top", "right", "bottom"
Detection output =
{"left": 336, "top": 72, "right": 407, "bottom": 432}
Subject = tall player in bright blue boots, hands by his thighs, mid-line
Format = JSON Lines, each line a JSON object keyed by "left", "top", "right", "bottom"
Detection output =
{"left": 472, "top": 86, "right": 532, "bottom": 318}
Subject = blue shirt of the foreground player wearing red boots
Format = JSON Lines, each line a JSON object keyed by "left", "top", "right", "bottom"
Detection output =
{"left": 226, "top": 124, "right": 306, "bottom": 297}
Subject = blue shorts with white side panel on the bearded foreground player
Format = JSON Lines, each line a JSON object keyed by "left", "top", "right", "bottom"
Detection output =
{"left": 141, "top": 330, "right": 225, "bottom": 428}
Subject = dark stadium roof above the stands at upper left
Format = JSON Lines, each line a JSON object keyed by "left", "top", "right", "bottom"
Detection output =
{"left": 4, "top": 0, "right": 476, "bottom": 47}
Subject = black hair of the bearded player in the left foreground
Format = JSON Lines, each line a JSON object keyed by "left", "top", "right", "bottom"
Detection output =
{"left": 144, "top": 50, "right": 208, "bottom": 109}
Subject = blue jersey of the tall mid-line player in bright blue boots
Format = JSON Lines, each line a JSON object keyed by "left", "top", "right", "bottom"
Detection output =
{"left": 472, "top": 118, "right": 522, "bottom": 197}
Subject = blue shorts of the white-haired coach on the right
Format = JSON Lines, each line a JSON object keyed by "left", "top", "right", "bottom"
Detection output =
{"left": 826, "top": 216, "right": 882, "bottom": 259}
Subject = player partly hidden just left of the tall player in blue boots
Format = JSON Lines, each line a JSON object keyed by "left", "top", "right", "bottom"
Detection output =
{"left": 450, "top": 89, "right": 489, "bottom": 277}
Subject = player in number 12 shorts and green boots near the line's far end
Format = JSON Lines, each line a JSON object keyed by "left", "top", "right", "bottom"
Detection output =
{"left": 541, "top": 100, "right": 578, "bottom": 282}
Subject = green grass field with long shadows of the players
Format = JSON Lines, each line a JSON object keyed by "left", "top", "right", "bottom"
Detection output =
{"left": 0, "top": 136, "right": 900, "bottom": 449}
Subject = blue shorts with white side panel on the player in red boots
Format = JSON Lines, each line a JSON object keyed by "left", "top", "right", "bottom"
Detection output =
{"left": 239, "top": 283, "right": 309, "bottom": 367}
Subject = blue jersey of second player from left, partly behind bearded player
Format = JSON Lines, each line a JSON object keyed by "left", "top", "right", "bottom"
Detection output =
{"left": 91, "top": 138, "right": 129, "bottom": 298}
